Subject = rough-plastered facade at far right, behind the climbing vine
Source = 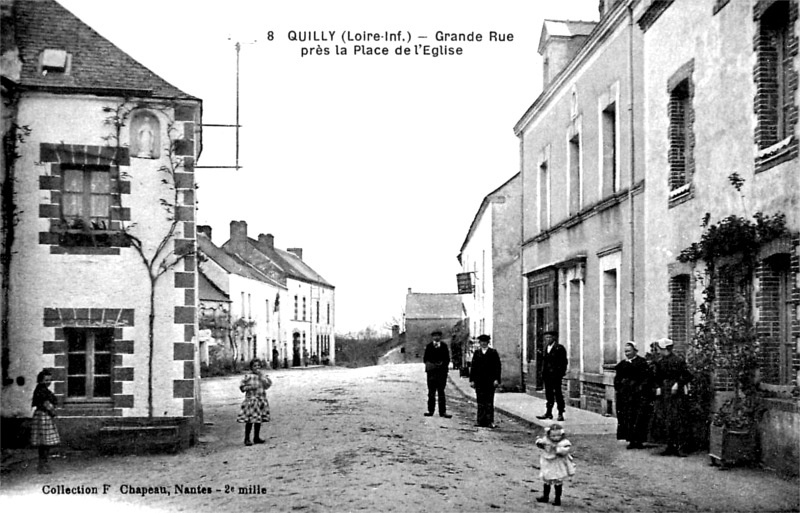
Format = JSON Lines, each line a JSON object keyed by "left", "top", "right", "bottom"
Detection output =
{"left": 637, "top": 0, "right": 800, "bottom": 474}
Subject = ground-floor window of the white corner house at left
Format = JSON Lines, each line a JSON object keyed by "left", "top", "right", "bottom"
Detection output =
{"left": 64, "top": 328, "right": 114, "bottom": 400}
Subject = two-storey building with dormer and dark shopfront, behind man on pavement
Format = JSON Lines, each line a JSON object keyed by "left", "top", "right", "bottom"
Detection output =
{"left": 515, "top": 2, "right": 645, "bottom": 414}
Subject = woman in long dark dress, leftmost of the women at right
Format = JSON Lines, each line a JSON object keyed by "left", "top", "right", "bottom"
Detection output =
{"left": 614, "top": 342, "right": 650, "bottom": 449}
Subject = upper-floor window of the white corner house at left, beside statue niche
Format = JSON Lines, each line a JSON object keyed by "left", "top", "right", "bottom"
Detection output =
{"left": 61, "top": 166, "right": 111, "bottom": 231}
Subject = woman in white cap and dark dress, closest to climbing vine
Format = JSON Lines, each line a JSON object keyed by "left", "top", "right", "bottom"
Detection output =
{"left": 654, "top": 338, "right": 692, "bottom": 456}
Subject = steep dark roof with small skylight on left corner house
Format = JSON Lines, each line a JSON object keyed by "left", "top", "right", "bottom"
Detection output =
{"left": 9, "top": 0, "right": 199, "bottom": 101}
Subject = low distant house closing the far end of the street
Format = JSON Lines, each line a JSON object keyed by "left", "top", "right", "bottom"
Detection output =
{"left": 405, "top": 289, "right": 462, "bottom": 361}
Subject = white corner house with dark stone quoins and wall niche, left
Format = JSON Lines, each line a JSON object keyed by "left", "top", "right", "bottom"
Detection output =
{"left": 0, "top": 0, "right": 202, "bottom": 447}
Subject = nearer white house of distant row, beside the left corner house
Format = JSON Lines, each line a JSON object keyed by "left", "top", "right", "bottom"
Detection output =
{"left": 197, "top": 226, "right": 288, "bottom": 364}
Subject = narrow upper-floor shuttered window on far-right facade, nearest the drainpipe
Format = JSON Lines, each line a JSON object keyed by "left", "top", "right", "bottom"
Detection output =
{"left": 669, "top": 79, "right": 693, "bottom": 191}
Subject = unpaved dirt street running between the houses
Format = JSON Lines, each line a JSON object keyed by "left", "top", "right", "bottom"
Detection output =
{"left": 0, "top": 364, "right": 797, "bottom": 512}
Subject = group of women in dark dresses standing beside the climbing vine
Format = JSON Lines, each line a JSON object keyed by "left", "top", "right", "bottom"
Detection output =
{"left": 614, "top": 338, "right": 692, "bottom": 456}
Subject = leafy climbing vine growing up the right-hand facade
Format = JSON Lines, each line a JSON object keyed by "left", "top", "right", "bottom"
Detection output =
{"left": 678, "top": 174, "right": 790, "bottom": 439}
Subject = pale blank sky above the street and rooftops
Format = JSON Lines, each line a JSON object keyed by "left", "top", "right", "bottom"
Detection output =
{"left": 58, "top": 0, "right": 598, "bottom": 333}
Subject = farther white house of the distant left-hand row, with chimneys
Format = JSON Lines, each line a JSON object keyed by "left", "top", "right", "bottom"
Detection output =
{"left": 222, "top": 221, "right": 336, "bottom": 366}
